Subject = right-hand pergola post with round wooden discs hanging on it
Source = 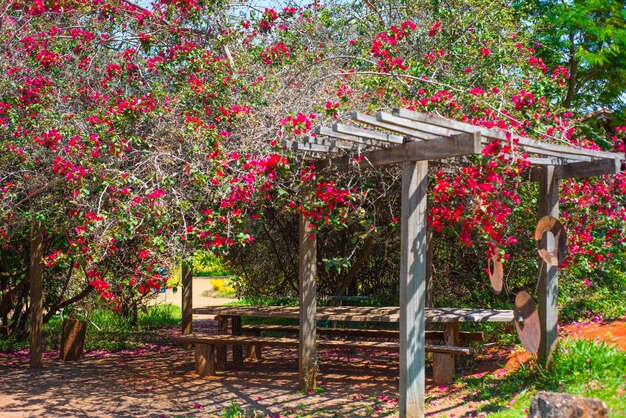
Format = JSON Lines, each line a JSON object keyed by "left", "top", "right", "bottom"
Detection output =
{"left": 538, "top": 165, "right": 559, "bottom": 365}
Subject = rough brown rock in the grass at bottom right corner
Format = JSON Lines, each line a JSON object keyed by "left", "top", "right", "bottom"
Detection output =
{"left": 528, "top": 392, "right": 608, "bottom": 418}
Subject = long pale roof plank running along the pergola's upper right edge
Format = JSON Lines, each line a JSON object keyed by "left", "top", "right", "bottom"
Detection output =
{"left": 393, "top": 109, "right": 624, "bottom": 161}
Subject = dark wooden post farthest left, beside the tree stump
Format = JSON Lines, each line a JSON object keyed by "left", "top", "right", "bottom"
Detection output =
{"left": 28, "top": 228, "right": 43, "bottom": 368}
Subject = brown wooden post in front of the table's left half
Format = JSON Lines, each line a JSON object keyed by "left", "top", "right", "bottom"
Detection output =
{"left": 298, "top": 215, "right": 317, "bottom": 391}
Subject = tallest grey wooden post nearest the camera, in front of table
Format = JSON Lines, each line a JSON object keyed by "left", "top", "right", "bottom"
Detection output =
{"left": 400, "top": 161, "right": 428, "bottom": 418}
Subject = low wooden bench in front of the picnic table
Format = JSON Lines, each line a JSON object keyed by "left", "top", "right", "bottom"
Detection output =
{"left": 174, "top": 334, "right": 474, "bottom": 376}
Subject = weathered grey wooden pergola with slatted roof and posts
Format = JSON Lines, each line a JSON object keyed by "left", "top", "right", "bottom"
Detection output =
{"left": 173, "top": 109, "right": 624, "bottom": 417}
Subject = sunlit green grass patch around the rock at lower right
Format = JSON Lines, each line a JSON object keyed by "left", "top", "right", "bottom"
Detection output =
{"left": 460, "top": 340, "right": 626, "bottom": 418}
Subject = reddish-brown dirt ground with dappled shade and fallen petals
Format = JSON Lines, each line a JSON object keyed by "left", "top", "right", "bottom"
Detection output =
{"left": 0, "top": 279, "right": 626, "bottom": 418}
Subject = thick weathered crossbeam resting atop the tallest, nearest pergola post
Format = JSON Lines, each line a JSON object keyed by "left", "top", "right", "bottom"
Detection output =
{"left": 343, "top": 133, "right": 482, "bottom": 167}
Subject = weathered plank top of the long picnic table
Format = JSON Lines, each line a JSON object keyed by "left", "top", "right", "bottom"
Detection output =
{"left": 193, "top": 306, "right": 513, "bottom": 322}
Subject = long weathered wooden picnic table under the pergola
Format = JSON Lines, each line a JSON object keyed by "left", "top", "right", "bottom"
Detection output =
{"left": 193, "top": 306, "right": 513, "bottom": 384}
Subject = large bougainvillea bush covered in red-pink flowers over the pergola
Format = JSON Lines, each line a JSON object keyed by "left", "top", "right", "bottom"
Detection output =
{"left": 0, "top": 0, "right": 624, "bottom": 329}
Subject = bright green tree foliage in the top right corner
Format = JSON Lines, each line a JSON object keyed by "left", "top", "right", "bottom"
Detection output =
{"left": 516, "top": 0, "right": 626, "bottom": 109}
